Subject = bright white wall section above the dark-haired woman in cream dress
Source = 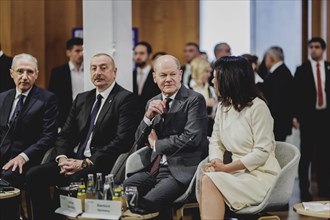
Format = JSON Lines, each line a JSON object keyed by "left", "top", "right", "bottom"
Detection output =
{"left": 200, "top": 0, "right": 250, "bottom": 61}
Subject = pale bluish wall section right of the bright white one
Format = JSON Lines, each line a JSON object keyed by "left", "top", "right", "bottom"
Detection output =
{"left": 251, "top": 0, "right": 302, "bottom": 74}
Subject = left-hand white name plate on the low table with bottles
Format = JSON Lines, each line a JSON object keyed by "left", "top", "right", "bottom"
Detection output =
{"left": 55, "top": 195, "right": 82, "bottom": 217}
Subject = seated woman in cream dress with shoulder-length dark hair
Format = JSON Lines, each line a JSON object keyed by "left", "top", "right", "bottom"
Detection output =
{"left": 199, "top": 56, "right": 280, "bottom": 220}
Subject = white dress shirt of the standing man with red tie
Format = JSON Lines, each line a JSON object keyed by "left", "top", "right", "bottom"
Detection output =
{"left": 310, "top": 59, "right": 327, "bottom": 110}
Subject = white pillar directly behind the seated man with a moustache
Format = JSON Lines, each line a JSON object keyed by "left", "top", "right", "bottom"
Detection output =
{"left": 83, "top": 0, "right": 133, "bottom": 91}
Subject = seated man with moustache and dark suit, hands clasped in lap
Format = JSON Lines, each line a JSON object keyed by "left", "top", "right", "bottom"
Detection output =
{"left": 27, "top": 53, "right": 138, "bottom": 219}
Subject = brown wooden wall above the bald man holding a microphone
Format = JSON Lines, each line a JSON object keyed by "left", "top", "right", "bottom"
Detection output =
{"left": 132, "top": 0, "right": 199, "bottom": 63}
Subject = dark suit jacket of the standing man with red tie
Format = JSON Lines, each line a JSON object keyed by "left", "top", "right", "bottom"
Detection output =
{"left": 294, "top": 61, "right": 330, "bottom": 123}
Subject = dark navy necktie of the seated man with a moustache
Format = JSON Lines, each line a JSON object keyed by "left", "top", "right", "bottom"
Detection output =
{"left": 77, "top": 94, "right": 103, "bottom": 159}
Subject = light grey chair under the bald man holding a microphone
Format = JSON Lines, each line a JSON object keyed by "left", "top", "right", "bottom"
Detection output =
{"left": 125, "top": 147, "right": 198, "bottom": 219}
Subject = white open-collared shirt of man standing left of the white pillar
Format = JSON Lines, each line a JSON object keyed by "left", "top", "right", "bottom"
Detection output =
{"left": 69, "top": 61, "right": 84, "bottom": 100}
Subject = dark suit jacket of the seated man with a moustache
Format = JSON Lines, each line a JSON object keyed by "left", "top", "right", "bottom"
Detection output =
{"left": 55, "top": 84, "right": 138, "bottom": 172}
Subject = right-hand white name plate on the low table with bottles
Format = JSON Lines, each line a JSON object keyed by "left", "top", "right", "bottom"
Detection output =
{"left": 81, "top": 199, "right": 121, "bottom": 220}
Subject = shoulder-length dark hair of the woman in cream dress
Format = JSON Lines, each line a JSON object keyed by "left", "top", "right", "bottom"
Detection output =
{"left": 214, "top": 56, "right": 266, "bottom": 112}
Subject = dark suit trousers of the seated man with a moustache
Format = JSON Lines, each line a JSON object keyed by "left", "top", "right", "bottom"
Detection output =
{"left": 26, "top": 161, "right": 98, "bottom": 219}
